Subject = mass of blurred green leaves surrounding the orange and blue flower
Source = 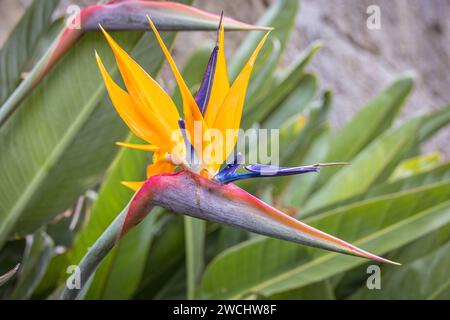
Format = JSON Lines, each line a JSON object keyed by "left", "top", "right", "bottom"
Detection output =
{"left": 0, "top": 0, "right": 450, "bottom": 299}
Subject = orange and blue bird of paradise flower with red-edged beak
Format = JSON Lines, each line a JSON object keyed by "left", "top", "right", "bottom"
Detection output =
{"left": 97, "top": 18, "right": 396, "bottom": 264}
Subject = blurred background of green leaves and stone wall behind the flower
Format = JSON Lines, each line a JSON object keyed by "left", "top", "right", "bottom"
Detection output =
{"left": 0, "top": 0, "right": 450, "bottom": 299}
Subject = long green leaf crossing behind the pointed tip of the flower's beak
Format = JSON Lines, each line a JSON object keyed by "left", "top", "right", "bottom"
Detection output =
{"left": 202, "top": 182, "right": 450, "bottom": 298}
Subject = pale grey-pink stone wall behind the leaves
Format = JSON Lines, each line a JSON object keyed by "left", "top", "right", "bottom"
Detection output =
{"left": 0, "top": 0, "right": 450, "bottom": 159}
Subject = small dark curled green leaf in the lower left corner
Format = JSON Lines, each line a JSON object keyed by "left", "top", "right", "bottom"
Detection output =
{"left": 10, "top": 232, "right": 54, "bottom": 300}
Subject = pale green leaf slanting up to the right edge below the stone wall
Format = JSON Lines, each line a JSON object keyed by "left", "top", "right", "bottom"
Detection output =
{"left": 305, "top": 106, "right": 450, "bottom": 215}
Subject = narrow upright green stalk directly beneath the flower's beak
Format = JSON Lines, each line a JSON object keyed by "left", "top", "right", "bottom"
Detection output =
{"left": 184, "top": 217, "right": 206, "bottom": 299}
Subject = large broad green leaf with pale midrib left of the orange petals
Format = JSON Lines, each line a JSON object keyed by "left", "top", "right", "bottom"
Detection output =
{"left": 0, "top": 33, "right": 171, "bottom": 247}
